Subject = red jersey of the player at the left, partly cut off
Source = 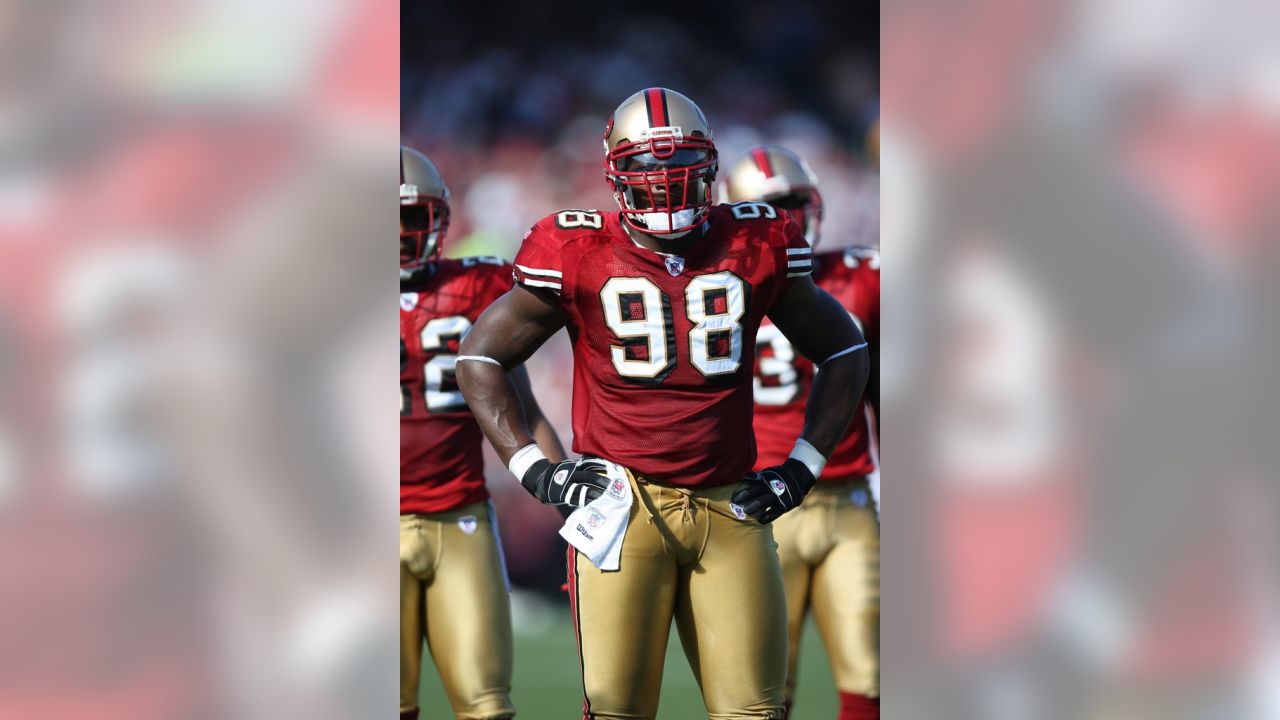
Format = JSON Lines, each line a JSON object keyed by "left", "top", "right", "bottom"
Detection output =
{"left": 401, "top": 258, "right": 511, "bottom": 515}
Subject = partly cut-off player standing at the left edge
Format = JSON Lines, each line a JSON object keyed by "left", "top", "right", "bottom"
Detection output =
{"left": 401, "top": 146, "right": 564, "bottom": 720}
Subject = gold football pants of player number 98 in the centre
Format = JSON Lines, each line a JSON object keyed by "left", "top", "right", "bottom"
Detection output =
{"left": 568, "top": 479, "right": 786, "bottom": 720}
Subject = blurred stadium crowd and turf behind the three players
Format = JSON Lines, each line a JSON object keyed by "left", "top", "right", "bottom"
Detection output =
{"left": 401, "top": 0, "right": 879, "bottom": 717}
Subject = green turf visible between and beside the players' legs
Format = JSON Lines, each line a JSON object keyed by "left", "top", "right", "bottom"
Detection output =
{"left": 421, "top": 591, "right": 837, "bottom": 720}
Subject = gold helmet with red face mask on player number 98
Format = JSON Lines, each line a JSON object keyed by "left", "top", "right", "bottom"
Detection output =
{"left": 604, "top": 87, "right": 718, "bottom": 237}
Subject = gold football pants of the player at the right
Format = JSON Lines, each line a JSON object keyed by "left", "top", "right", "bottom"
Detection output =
{"left": 773, "top": 478, "right": 879, "bottom": 700}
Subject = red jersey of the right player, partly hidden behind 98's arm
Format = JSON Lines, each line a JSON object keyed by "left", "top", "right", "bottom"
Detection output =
{"left": 755, "top": 247, "right": 879, "bottom": 482}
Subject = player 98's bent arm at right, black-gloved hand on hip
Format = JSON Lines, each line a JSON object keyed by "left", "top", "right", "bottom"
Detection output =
{"left": 733, "top": 277, "right": 870, "bottom": 523}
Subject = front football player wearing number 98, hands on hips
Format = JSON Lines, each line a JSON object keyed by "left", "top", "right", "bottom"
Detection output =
{"left": 458, "top": 87, "right": 868, "bottom": 719}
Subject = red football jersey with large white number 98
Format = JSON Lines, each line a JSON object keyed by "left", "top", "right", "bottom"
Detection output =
{"left": 515, "top": 202, "right": 813, "bottom": 487}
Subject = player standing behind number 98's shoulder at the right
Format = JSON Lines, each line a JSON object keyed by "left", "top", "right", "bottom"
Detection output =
{"left": 722, "top": 146, "right": 879, "bottom": 720}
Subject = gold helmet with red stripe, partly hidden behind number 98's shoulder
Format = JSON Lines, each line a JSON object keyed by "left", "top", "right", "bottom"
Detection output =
{"left": 721, "top": 145, "right": 823, "bottom": 247}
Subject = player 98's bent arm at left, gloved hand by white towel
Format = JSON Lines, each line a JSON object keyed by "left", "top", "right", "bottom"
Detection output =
{"left": 456, "top": 286, "right": 605, "bottom": 507}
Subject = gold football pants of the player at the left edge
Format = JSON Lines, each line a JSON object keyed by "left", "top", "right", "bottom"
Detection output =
{"left": 401, "top": 502, "right": 515, "bottom": 720}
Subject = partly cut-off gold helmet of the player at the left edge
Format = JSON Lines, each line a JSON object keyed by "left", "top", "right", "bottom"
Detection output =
{"left": 401, "top": 145, "right": 449, "bottom": 278}
